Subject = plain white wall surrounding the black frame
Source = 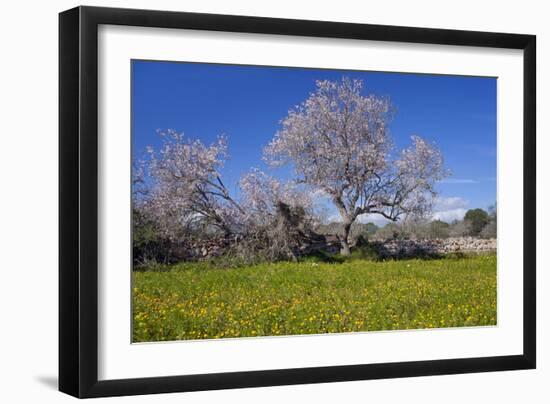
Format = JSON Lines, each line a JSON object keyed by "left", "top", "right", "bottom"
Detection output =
{"left": 0, "top": 0, "right": 550, "bottom": 403}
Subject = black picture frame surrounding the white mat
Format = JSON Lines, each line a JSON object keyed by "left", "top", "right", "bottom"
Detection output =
{"left": 59, "top": 7, "right": 536, "bottom": 398}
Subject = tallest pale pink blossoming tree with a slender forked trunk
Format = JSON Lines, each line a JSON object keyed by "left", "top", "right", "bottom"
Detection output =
{"left": 264, "top": 78, "right": 446, "bottom": 255}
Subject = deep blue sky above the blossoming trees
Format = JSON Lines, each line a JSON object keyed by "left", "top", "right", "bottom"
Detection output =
{"left": 132, "top": 61, "right": 497, "bottom": 224}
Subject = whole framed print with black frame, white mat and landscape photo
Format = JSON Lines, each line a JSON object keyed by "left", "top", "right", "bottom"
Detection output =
{"left": 59, "top": 7, "right": 536, "bottom": 398}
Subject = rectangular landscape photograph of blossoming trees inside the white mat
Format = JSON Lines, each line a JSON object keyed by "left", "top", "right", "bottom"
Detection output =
{"left": 133, "top": 59, "right": 500, "bottom": 343}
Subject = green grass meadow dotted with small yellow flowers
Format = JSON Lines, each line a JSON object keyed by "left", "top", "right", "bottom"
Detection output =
{"left": 133, "top": 255, "right": 496, "bottom": 342}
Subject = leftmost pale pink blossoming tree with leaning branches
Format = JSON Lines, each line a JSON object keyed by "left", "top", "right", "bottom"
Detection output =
{"left": 142, "top": 130, "right": 244, "bottom": 238}
